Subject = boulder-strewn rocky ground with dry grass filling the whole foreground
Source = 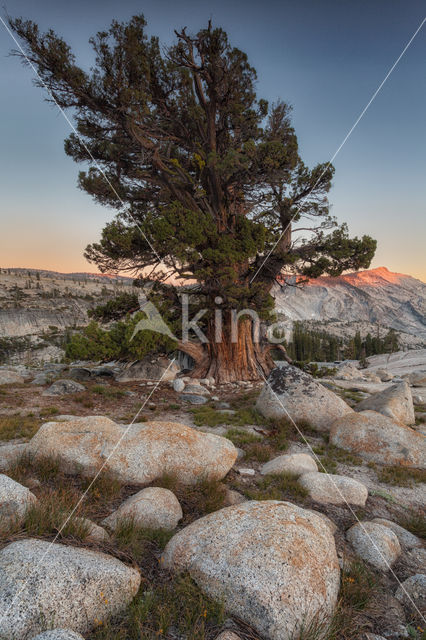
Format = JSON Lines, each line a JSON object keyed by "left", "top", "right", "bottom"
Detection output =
{"left": 0, "top": 354, "right": 426, "bottom": 640}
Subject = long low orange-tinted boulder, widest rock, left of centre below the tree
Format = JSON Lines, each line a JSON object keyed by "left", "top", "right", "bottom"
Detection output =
{"left": 27, "top": 416, "right": 237, "bottom": 484}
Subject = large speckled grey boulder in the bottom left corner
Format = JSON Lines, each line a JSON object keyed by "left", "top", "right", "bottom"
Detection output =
{"left": 0, "top": 539, "right": 141, "bottom": 640}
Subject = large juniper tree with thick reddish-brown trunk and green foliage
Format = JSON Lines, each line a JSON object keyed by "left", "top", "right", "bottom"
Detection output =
{"left": 10, "top": 15, "right": 376, "bottom": 381}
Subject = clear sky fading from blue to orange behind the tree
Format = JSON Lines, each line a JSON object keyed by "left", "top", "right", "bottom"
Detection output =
{"left": 0, "top": 0, "right": 426, "bottom": 280}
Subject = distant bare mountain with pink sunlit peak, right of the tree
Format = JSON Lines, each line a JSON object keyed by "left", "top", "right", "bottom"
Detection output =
{"left": 273, "top": 267, "right": 426, "bottom": 346}
